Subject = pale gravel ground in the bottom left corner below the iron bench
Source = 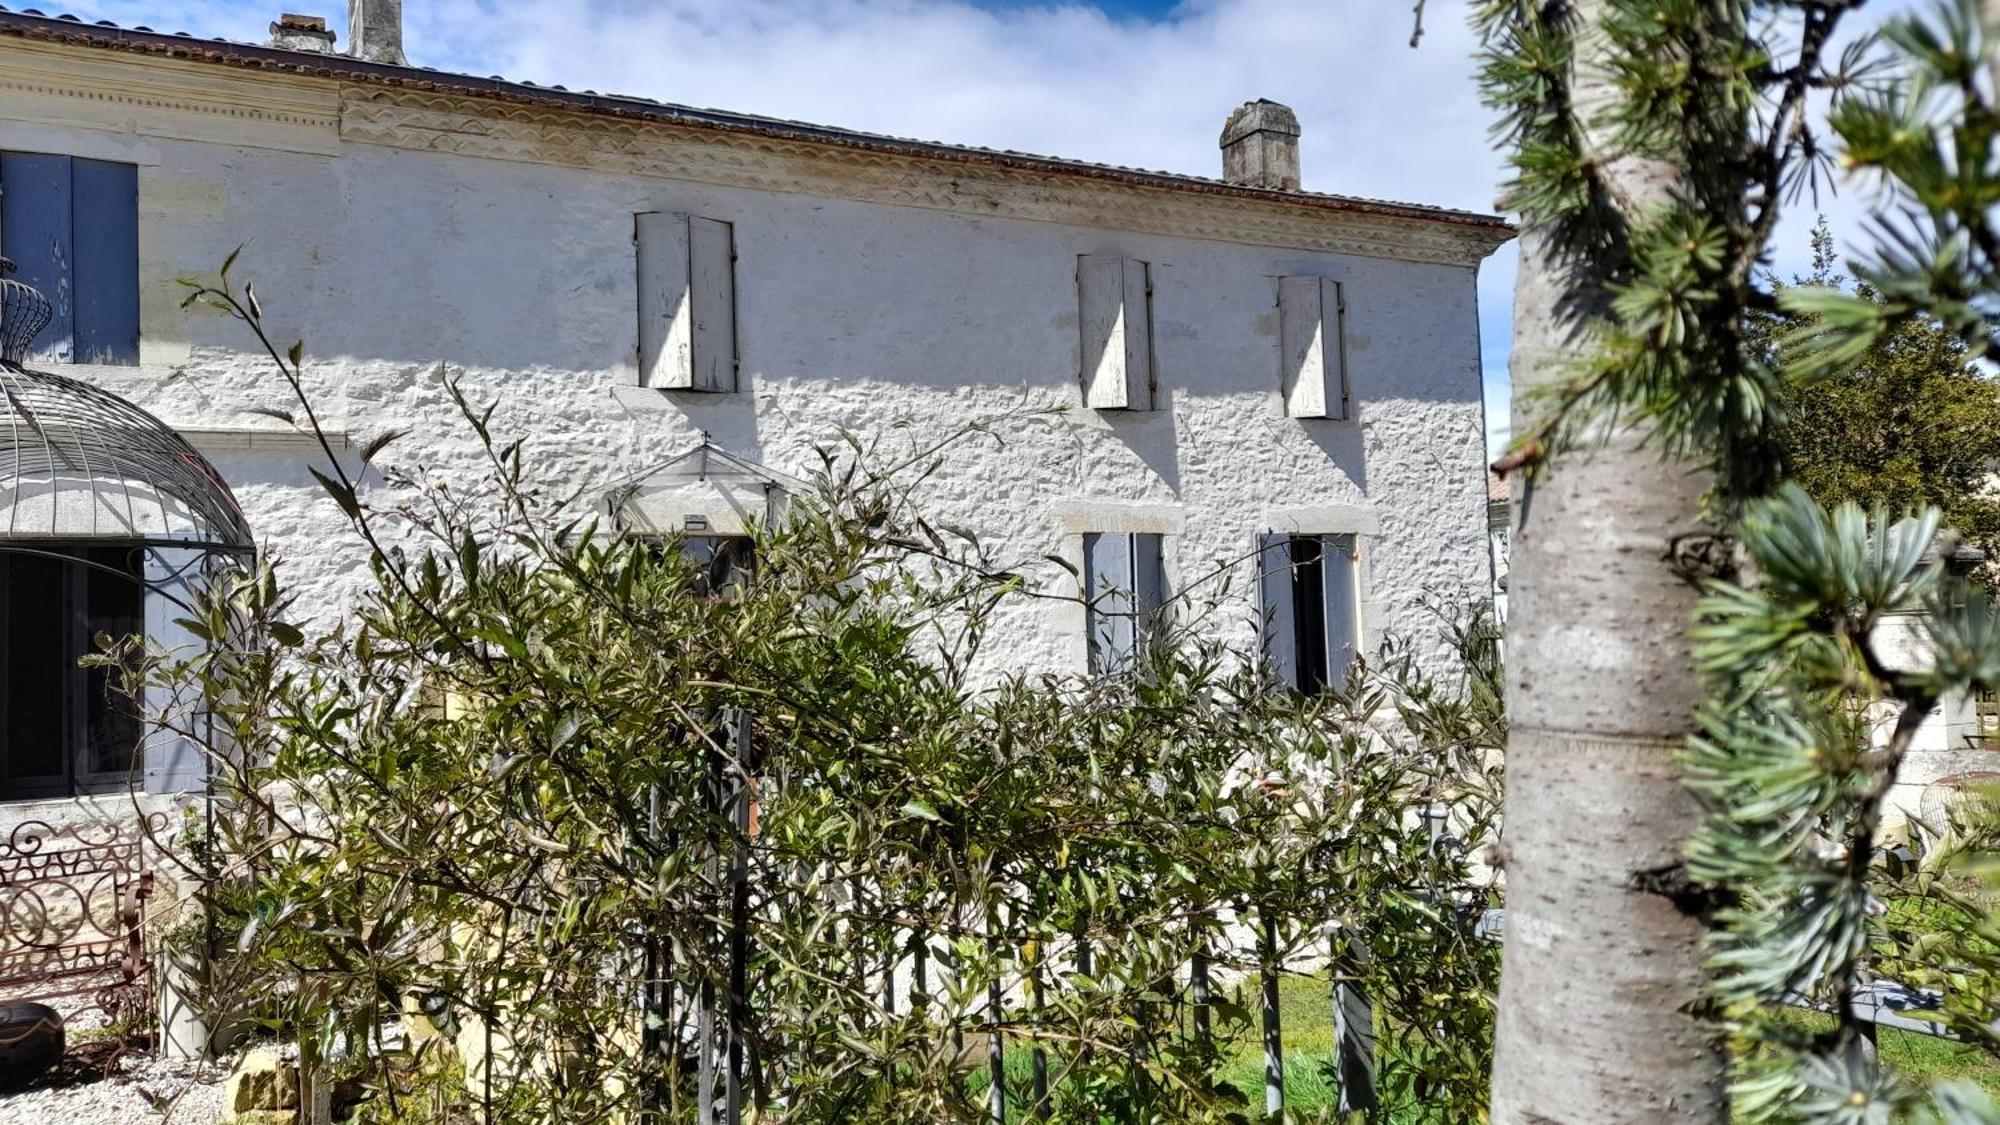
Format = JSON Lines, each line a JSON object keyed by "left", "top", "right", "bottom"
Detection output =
{"left": 0, "top": 1051, "right": 226, "bottom": 1125}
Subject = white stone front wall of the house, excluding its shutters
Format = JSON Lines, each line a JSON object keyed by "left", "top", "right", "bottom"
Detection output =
{"left": 0, "top": 16, "right": 1510, "bottom": 704}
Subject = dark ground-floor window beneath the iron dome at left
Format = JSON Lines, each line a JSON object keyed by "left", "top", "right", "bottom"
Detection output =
{"left": 0, "top": 544, "right": 146, "bottom": 797}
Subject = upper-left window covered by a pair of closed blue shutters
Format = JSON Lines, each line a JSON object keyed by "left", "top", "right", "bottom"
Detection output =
{"left": 0, "top": 152, "right": 138, "bottom": 364}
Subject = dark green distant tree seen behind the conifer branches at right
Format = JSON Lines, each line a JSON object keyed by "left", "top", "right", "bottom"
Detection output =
{"left": 1756, "top": 222, "right": 2000, "bottom": 558}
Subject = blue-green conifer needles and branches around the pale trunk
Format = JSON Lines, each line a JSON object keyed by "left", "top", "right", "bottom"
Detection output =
{"left": 1476, "top": 0, "right": 2000, "bottom": 1121}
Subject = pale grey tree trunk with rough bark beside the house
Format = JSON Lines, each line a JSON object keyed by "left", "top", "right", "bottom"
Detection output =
{"left": 1492, "top": 0, "right": 1728, "bottom": 1125}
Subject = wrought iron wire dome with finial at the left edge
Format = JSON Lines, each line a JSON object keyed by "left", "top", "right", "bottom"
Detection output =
{"left": 0, "top": 258, "right": 254, "bottom": 552}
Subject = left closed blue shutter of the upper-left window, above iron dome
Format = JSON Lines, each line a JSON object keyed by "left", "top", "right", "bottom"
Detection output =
{"left": 0, "top": 152, "right": 76, "bottom": 362}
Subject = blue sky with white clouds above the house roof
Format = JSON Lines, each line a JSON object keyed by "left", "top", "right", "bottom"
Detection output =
{"left": 50, "top": 0, "right": 1908, "bottom": 456}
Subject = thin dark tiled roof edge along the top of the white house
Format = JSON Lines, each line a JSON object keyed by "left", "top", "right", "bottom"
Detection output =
{"left": 0, "top": 6, "right": 1514, "bottom": 246}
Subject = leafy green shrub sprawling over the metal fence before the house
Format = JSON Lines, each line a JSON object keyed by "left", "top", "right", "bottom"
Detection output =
{"left": 121, "top": 268, "right": 1504, "bottom": 1121}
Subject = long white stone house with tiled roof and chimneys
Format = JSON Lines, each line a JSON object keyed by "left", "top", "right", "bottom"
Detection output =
{"left": 0, "top": 0, "right": 1512, "bottom": 817}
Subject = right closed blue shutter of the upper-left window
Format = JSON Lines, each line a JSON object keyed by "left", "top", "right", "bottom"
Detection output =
{"left": 70, "top": 158, "right": 138, "bottom": 364}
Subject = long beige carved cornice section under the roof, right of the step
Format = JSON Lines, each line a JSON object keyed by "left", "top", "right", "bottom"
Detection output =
{"left": 340, "top": 84, "right": 1512, "bottom": 266}
